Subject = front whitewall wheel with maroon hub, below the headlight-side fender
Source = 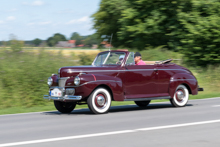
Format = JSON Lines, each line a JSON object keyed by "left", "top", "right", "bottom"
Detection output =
{"left": 87, "top": 88, "right": 111, "bottom": 114}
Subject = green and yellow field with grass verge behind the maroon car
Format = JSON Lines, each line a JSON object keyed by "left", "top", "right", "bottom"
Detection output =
{"left": 0, "top": 48, "right": 220, "bottom": 114}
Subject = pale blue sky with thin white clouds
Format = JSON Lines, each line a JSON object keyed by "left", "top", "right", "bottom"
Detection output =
{"left": 0, "top": 0, "right": 101, "bottom": 41}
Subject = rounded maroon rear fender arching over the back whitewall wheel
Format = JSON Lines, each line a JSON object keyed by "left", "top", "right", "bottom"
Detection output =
{"left": 169, "top": 73, "right": 198, "bottom": 97}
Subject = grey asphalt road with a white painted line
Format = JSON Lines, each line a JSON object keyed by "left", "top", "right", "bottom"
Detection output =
{"left": 0, "top": 98, "right": 220, "bottom": 147}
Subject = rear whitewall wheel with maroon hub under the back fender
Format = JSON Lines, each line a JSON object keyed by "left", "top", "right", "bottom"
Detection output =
{"left": 170, "top": 85, "right": 189, "bottom": 107}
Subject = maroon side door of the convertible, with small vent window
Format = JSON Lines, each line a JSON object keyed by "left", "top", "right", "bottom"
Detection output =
{"left": 123, "top": 53, "right": 158, "bottom": 99}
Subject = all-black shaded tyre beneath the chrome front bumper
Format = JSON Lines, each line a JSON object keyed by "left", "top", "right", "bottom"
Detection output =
{"left": 54, "top": 101, "right": 76, "bottom": 113}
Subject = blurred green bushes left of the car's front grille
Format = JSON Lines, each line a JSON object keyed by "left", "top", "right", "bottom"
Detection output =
{"left": 0, "top": 50, "right": 74, "bottom": 109}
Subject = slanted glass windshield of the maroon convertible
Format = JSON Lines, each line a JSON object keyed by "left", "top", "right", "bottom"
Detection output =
{"left": 93, "top": 52, "right": 125, "bottom": 66}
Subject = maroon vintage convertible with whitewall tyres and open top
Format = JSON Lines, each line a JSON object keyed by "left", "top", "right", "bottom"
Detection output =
{"left": 44, "top": 51, "right": 203, "bottom": 114}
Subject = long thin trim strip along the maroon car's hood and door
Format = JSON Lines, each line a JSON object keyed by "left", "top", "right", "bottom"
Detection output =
{"left": 67, "top": 69, "right": 188, "bottom": 73}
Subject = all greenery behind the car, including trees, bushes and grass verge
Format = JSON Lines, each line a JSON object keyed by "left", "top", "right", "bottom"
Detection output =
{"left": 0, "top": 0, "right": 220, "bottom": 114}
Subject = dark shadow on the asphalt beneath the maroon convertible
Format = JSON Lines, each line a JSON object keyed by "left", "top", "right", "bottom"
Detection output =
{"left": 43, "top": 103, "right": 193, "bottom": 115}
